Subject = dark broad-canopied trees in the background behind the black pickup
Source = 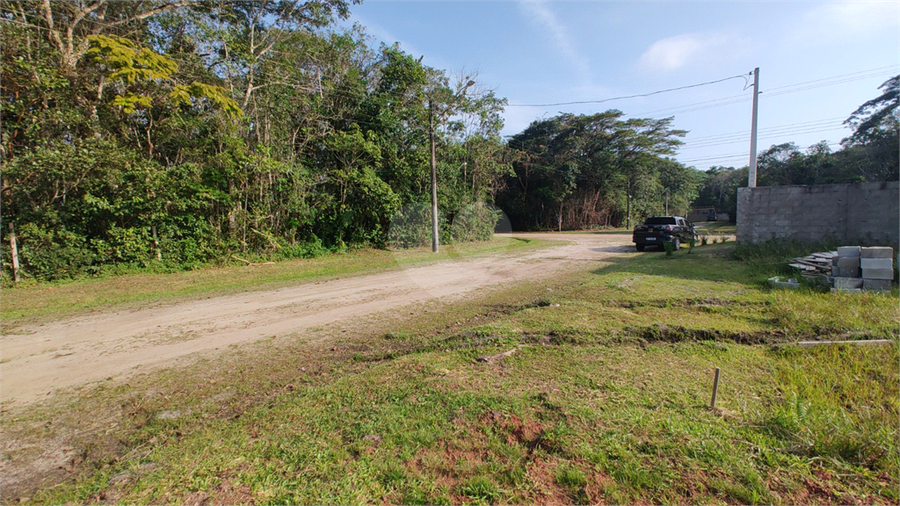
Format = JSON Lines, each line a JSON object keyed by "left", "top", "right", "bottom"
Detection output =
{"left": 497, "top": 110, "right": 700, "bottom": 230}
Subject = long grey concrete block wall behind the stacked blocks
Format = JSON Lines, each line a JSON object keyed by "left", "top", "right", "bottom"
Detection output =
{"left": 737, "top": 181, "right": 900, "bottom": 245}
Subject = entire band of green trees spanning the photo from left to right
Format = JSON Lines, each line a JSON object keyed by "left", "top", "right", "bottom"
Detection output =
{"left": 0, "top": 0, "right": 900, "bottom": 279}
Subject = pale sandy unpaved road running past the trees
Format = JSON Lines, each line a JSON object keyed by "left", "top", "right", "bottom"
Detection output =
{"left": 0, "top": 234, "right": 633, "bottom": 406}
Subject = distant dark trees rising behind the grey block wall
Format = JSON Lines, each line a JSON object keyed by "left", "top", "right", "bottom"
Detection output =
{"left": 695, "top": 75, "right": 900, "bottom": 219}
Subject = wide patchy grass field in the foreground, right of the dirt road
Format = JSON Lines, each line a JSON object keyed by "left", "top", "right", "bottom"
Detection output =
{"left": 3, "top": 239, "right": 900, "bottom": 504}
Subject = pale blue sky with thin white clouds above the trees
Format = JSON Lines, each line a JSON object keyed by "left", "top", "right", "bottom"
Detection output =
{"left": 349, "top": 0, "right": 900, "bottom": 170}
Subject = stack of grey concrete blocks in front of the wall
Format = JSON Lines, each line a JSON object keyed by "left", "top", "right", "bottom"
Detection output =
{"left": 832, "top": 246, "right": 894, "bottom": 292}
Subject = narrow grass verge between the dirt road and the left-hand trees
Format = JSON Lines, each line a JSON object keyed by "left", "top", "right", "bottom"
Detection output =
{"left": 0, "top": 238, "right": 548, "bottom": 331}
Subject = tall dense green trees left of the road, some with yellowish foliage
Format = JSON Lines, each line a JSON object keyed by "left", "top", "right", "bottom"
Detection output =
{"left": 0, "top": 0, "right": 508, "bottom": 279}
